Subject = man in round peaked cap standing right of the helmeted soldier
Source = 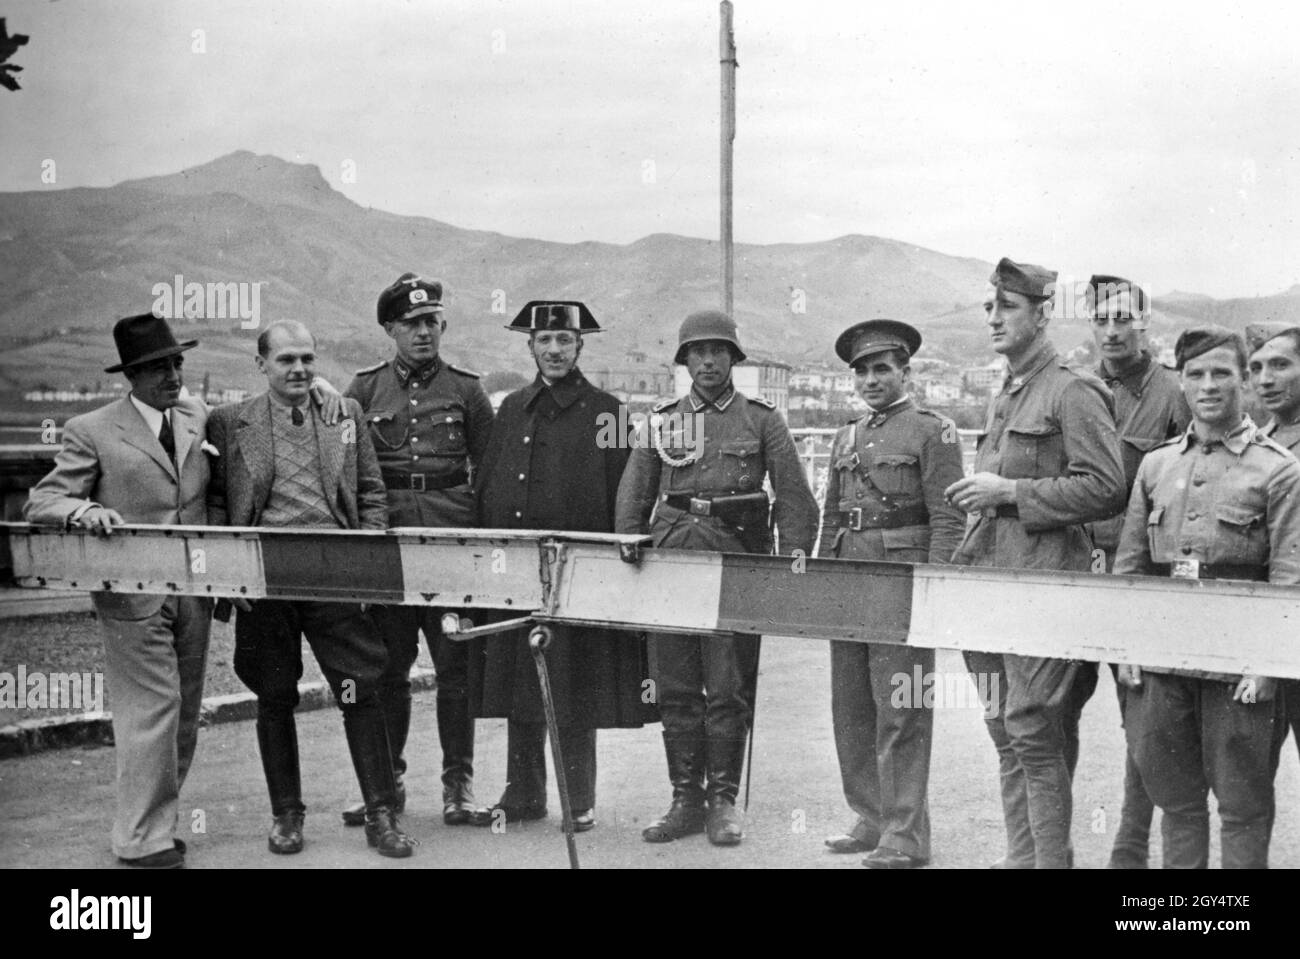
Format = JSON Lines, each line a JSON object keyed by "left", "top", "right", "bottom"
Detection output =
{"left": 820, "top": 320, "right": 966, "bottom": 869}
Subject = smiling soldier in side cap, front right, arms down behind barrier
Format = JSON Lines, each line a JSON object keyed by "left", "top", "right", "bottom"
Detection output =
{"left": 1115, "top": 326, "right": 1300, "bottom": 869}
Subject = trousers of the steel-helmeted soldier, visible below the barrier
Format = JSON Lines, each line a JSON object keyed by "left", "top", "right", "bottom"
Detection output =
{"left": 647, "top": 633, "right": 758, "bottom": 741}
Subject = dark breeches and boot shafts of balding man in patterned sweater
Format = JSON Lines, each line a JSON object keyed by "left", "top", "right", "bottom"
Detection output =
{"left": 234, "top": 599, "right": 393, "bottom": 815}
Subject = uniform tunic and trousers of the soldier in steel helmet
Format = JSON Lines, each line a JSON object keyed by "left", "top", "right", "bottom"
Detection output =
{"left": 615, "top": 383, "right": 818, "bottom": 753}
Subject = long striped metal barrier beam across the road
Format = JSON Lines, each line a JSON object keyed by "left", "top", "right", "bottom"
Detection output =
{"left": 0, "top": 524, "right": 1300, "bottom": 678}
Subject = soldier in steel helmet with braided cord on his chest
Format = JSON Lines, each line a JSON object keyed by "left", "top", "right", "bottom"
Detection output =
{"left": 616, "top": 309, "right": 818, "bottom": 846}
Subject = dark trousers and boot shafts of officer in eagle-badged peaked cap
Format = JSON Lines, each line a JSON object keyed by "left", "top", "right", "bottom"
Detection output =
{"left": 373, "top": 606, "right": 475, "bottom": 786}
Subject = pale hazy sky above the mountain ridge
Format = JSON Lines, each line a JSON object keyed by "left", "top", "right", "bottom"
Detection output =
{"left": 0, "top": 0, "right": 1300, "bottom": 296}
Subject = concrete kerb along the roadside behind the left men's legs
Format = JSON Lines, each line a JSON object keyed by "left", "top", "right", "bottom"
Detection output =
{"left": 0, "top": 669, "right": 438, "bottom": 759}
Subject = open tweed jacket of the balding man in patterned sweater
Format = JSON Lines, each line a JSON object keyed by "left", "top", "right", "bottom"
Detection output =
{"left": 208, "top": 392, "right": 389, "bottom": 529}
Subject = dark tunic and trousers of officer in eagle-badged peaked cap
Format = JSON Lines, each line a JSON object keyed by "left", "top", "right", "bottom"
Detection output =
{"left": 343, "top": 357, "right": 493, "bottom": 787}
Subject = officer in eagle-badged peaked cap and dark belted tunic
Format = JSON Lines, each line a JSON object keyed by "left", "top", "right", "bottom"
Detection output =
{"left": 343, "top": 273, "right": 493, "bottom": 825}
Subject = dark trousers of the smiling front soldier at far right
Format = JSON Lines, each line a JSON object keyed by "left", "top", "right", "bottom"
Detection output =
{"left": 1125, "top": 672, "right": 1283, "bottom": 869}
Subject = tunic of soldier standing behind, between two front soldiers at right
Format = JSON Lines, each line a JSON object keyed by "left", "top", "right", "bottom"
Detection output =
{"left": 1088, "top": 351, "right": 1192, "bottom": 553}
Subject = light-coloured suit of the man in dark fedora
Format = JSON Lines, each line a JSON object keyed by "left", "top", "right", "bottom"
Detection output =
{"left": 23, "top": 399, "right": 212, "bottom": 859}
